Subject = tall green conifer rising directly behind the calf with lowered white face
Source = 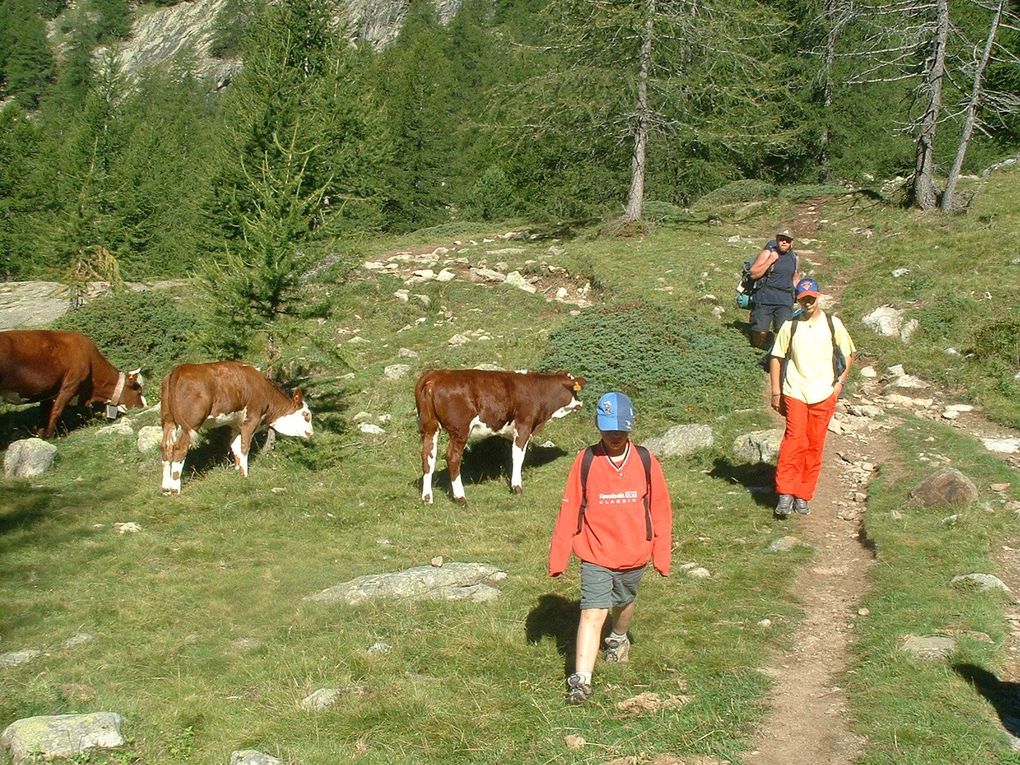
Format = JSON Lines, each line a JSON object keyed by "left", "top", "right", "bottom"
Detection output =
{"left": 203, "top": 0, "right": 383, "bottom": 365}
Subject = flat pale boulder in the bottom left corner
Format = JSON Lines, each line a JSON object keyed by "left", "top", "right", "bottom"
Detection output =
{"left": 0, "top": 712, "right": 124, "bottom": 765}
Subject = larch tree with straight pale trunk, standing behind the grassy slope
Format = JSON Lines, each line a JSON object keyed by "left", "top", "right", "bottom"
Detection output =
{"left": 507, "top": 0, "right": 785, "bottom": 225}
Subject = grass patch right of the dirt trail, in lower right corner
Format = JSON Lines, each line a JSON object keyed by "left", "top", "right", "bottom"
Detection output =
{"left": 849, "top": 422, "right": 1020, "bottom": 765}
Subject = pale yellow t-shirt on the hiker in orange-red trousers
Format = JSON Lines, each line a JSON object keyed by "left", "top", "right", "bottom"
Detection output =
{"left": 769, "top": 310, "right": 857, "bottom": 404}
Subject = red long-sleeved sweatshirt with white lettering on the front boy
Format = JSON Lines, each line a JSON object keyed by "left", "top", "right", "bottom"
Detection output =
{"left": 549, "top": 444, "right": 673, "bottom": 576}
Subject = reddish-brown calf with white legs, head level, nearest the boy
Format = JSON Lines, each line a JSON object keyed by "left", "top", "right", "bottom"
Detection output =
{"left": 414, "top": 369, "right": 584, "bottom": 505}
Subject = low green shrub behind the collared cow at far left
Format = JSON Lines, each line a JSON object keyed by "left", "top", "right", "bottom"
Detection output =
{"left": 53, "top": 291, "right": 194, "bottom": 390}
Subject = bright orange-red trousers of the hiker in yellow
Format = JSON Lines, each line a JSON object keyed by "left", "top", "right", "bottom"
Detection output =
{"left": 775, "top": 394, "right": 836, "bottom": 501}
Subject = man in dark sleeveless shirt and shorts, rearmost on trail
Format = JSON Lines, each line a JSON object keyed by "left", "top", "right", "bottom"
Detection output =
{"left": 751, "top": 228, "right": 801, "bottom": 348}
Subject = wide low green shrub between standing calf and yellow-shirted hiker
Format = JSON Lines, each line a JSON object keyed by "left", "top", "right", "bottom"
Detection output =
{"left": 541, "top": 304, "right": 764, "bottom": 422}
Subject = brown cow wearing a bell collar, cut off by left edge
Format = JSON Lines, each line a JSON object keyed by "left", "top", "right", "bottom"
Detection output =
{"left": 0, "top": 329, "right": 146, "bottom": 439}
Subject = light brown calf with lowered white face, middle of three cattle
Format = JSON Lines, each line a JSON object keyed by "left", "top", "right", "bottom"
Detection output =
{"left": 159, "top": 361, "right": 312, "bottom": 495}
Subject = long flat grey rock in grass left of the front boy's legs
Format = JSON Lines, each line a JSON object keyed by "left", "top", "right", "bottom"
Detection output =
{"left": 305, "top": 563, "right": 506, "bottom": 606}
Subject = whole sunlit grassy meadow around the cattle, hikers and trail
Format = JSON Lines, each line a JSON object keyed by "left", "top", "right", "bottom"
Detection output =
{"left": 0, "top": 172, "right": 1020, "bottom": 765}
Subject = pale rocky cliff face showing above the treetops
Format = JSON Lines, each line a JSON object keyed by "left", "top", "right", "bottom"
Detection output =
{"left": 107, "top": 0, "right": 462, "bottom": 88}
